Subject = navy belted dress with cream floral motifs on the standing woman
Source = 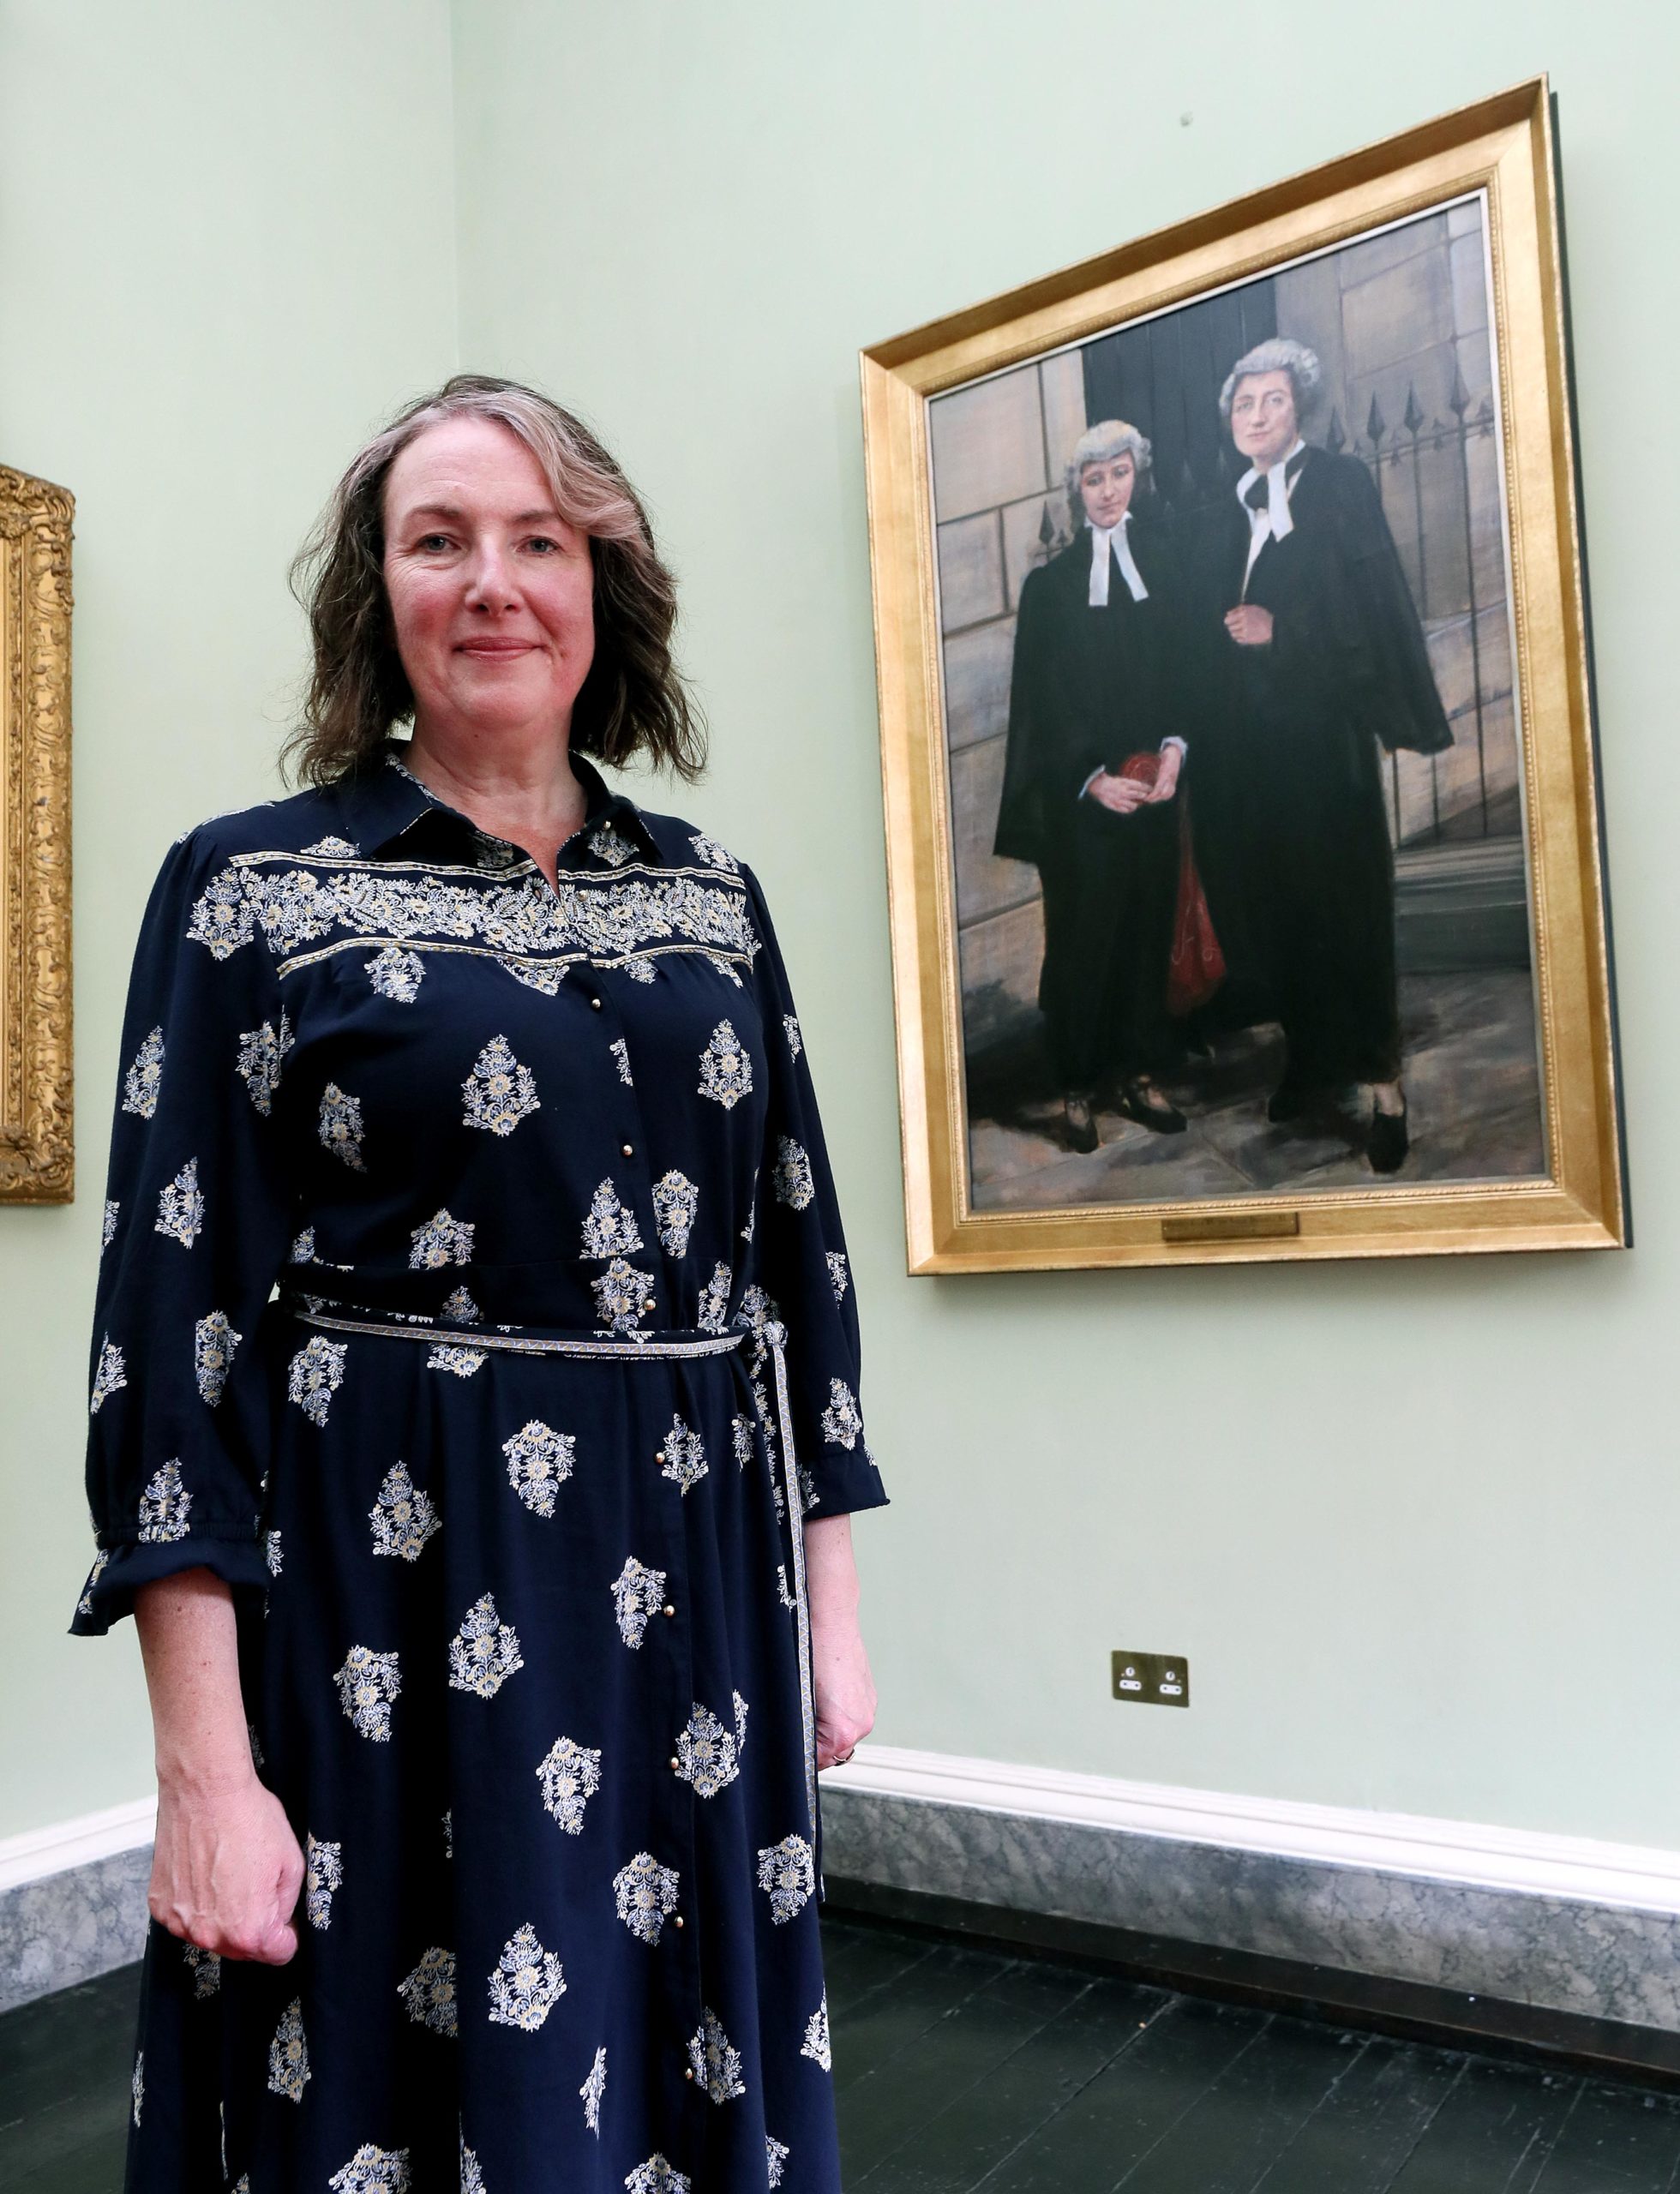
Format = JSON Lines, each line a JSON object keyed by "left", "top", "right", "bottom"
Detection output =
{"left": 75, "top": 746, "right": 886, "bottom": 2194}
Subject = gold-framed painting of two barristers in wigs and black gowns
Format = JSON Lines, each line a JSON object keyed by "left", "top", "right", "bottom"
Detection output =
{"left": 862, "top": 79, "right": 1628, "bottom": 1273}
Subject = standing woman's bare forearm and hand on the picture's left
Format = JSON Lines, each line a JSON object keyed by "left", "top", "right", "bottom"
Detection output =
{"left": 134, "top": 1568, "right": 305, "bottom": 1966}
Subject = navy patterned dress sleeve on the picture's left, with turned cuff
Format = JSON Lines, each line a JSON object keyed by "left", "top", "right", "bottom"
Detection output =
{"left": 70, "top": 825, "right": 291, "bottom": 1637}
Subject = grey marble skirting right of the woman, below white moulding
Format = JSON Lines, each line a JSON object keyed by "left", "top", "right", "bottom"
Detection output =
{"left": 823, "top": 1790, "right": 1680, "bottom": 2032}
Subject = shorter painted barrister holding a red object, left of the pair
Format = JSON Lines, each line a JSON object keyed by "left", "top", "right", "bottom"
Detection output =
{"left": 996, "top": 419, "right": 1185, "bottom": 1149}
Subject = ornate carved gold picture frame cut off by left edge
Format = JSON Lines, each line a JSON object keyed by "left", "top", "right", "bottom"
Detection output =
{"left": 0, "top": 465, "right": 75, "bottom": 1204}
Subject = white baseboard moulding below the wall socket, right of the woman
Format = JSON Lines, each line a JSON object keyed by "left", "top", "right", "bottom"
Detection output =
{"left": 823, "top": 1744, "right": 1680, "bottom": 1913}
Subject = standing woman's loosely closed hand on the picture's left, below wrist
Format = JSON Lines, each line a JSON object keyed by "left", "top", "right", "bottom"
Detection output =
{"left": 147, "top": 1771, "right": 305, "bottom": 1966}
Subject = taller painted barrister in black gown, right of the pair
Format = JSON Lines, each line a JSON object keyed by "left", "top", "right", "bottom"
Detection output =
{"left": 1193, "top": 338, "right": 1452, "bottom": 1172}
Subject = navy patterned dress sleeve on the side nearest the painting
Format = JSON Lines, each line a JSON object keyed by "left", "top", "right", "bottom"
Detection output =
{"left": 743, "top": 869, "right": 886, "bottom": 1516}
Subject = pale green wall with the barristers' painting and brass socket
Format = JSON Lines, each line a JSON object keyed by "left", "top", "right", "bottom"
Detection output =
{"left": 456, "top": 0, "right": 1680, "bottom": 1845}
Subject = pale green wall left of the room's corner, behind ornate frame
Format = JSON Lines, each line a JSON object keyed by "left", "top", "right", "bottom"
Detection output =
{"left": 0, "top": 0, "right": 454, "bottom": 1837}
